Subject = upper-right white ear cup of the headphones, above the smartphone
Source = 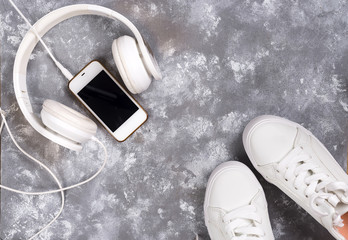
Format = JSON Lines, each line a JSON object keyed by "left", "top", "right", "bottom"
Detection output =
{"left": 112, "top": 36, "right": 151, "bottom": 94}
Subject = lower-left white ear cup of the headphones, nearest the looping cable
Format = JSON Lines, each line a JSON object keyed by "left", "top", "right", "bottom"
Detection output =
{"left": 41, "top": 99, "right": 97, "bottom": 143}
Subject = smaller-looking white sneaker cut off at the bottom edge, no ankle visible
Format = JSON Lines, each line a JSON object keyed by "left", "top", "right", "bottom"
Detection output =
{"left": 204, "top": 161, "right": 274, "bottom": 240}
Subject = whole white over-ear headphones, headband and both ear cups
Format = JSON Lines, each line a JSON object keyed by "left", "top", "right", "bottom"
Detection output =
{"left": 13, "top": 4, "right": 162, "bottom": 151}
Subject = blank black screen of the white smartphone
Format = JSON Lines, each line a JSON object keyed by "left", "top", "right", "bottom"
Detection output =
{"left": 78, "top": 70, "right": 139, "bottom": 132}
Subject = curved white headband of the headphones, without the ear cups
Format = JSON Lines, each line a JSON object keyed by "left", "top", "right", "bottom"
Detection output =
{"left": 13, "top": 4, "right": 161, "bottom": 151}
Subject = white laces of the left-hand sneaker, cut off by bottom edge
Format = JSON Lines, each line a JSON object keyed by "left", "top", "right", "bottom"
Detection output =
{"left": 223, "top": 205, "right": 265, "bottom": 240}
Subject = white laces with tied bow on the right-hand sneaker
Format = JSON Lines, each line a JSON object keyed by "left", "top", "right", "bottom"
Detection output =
{"left": 276, "top": 147, "right": 348, "bottom": 227}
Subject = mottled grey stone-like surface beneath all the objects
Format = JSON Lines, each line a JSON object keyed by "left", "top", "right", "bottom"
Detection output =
{"left": 0, "top": 0, "right": 348, "bottom": 240}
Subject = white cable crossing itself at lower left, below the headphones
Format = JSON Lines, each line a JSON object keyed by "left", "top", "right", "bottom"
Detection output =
{"left": 0, "top": 108, "right": 108, "bottom": 240}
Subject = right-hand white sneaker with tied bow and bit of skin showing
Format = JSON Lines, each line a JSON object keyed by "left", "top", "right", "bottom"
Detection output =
{"left": 243, "top": 116, "right": 348, "bottom": 240}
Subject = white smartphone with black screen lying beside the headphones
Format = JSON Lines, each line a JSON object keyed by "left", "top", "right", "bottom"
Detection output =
{"left": 69, "top": 61, "right": 147, "bottom": 142}
